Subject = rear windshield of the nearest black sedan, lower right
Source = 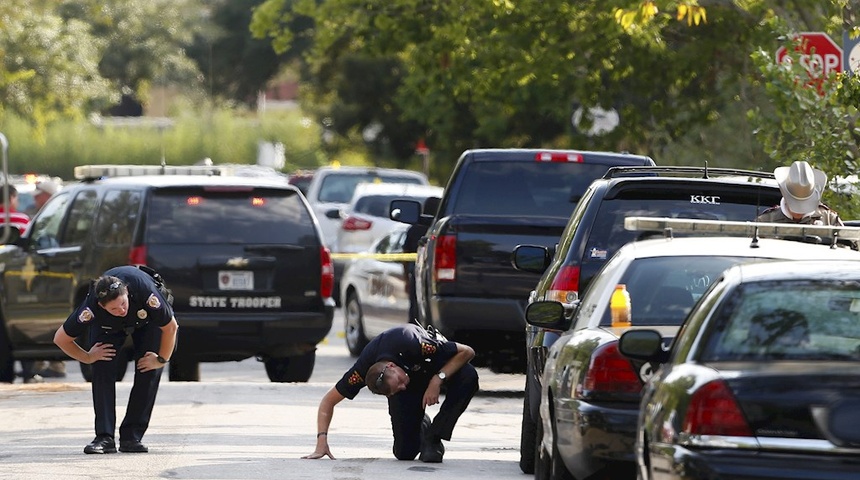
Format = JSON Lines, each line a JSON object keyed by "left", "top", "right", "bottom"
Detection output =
{"left": 700, "top": 280, "right": 860, "bottom": 362}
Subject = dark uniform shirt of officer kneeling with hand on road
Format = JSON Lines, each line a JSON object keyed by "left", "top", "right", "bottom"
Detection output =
{"left": 335, "top": 323, "right": 457, "bottom": 400}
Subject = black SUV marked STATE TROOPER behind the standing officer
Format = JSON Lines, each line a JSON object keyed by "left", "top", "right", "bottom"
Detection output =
{"left": 0, "top": 166, "right": 334, "bottom": 382}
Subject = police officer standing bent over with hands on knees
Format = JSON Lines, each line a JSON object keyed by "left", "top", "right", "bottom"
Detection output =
{"left": 54, "top": 266, "right": 179, "bottom": 453}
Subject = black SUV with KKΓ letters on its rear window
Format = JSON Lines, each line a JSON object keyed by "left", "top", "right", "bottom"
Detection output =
{"left": 513, "top": 166, "right": 782, "bottom": 473}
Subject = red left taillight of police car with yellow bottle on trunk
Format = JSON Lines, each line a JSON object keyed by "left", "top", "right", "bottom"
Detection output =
{"left": 576, "top": 342, "right": 642, "bottom": 397}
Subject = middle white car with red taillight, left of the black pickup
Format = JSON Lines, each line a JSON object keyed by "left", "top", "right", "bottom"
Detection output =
{"left": 334, "top": 183, "right": 444, "bottom": 253}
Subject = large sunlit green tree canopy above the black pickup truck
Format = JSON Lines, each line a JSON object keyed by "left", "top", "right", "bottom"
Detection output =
{"left": 245, "top": 0, "right": 784, "bottom": 176}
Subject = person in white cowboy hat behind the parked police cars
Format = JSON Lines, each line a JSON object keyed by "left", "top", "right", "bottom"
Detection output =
{"left": 757, "top": 161, "right": 842, "bottom": 225}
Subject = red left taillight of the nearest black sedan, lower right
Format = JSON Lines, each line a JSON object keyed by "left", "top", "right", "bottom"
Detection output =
{"left": 684, "top": 380, "right": 752, "bottom": 437}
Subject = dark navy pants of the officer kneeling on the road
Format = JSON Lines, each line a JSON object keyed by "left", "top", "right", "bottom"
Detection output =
{"left": 388, "top": 364, "right": 478, "bottom": 460}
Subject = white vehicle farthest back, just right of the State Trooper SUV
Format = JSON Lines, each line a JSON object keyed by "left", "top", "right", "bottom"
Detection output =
{"left": 305, "top": 166, "right": 430, "bottom": 252}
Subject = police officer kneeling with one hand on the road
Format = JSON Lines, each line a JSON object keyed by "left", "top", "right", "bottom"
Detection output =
{"left": 302, "top": 323, "right": 478, "bottom": 463}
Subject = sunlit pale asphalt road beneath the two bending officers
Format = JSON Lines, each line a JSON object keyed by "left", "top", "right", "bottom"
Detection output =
{"left": 0, "top": 324, "right": 526, "bottom": 480}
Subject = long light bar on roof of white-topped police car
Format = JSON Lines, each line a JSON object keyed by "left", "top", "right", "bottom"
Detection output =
{"left": 624, "top": 217, "right": 860, "bottom": 241}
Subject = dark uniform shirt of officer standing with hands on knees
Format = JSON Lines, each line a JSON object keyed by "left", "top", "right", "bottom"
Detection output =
{"left": 63, "top": 266, "right": 173, "bottom": 337}
